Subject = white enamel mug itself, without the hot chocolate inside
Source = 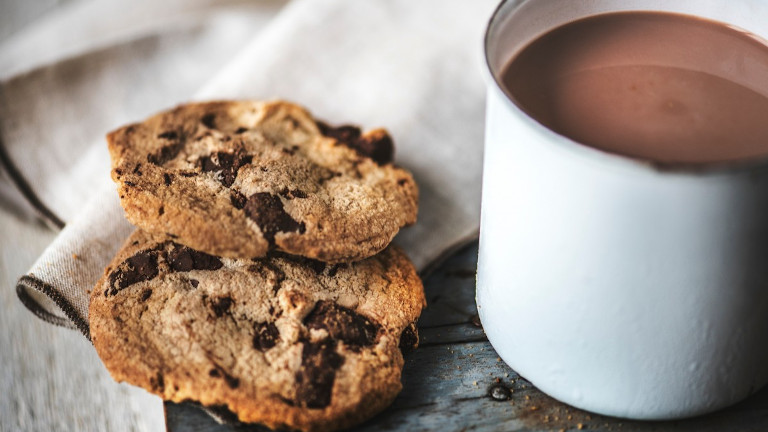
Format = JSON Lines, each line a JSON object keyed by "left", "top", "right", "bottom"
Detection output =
{"left": 477, "top": 0, "right": 768, "bottom": 419}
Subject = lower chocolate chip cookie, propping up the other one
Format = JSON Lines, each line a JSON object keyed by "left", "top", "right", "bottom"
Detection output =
{"left": 89, "top": 230, "right": 425, "bottom": 431}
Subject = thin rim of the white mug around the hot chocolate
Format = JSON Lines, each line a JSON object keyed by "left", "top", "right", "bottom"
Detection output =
{"left": 483, "top": 0, "right": 768, "bottom": 176}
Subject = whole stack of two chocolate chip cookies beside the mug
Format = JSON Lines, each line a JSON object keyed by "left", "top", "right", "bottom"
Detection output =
{"left": 90, "top": 101, "right": 425, "bottom": 431}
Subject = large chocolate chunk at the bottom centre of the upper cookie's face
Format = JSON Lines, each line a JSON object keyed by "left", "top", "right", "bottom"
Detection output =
{"left": 243, "top": 192, "right": 306, "bottom": 245}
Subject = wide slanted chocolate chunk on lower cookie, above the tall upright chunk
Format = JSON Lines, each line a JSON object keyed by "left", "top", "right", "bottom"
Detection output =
{"left": 304, "top": 300, "right": 379, "bottom": 349}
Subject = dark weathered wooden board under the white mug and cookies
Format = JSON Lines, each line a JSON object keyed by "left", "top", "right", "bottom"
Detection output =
{"left": 166, "top": 244, "right": 768, "bottom": 432}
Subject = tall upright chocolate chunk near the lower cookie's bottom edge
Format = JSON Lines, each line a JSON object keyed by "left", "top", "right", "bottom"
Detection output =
{"left": 295, "top": 339, "right": 344, "bottom": 408}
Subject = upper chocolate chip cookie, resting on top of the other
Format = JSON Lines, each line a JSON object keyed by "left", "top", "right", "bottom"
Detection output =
{"left": 107, "top": 101, "right": 418, "bottom": 263}
